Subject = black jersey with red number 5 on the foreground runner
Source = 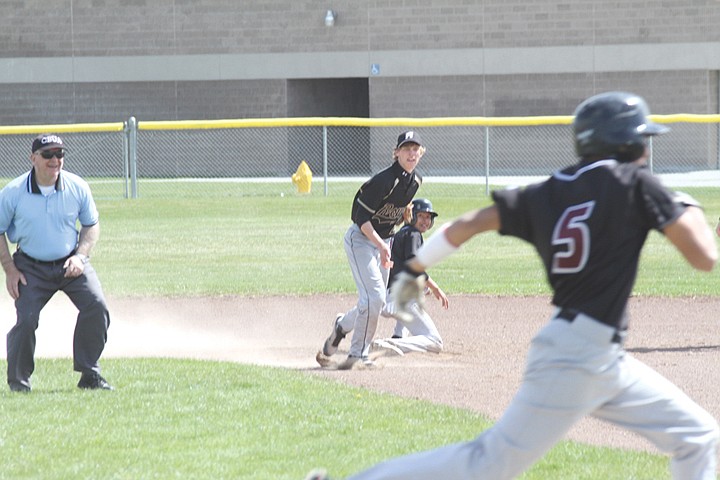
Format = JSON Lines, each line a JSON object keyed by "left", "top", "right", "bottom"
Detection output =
{"left": 493, "top": 160, "right": 685, "bottom": 329}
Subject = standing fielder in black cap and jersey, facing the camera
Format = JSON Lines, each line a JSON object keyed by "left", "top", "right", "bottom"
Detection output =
{"left": 316, "top": 131, "right": 425, "bottom": 369}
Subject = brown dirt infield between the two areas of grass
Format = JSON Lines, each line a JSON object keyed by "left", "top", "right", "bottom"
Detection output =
{"left": 0, "top": 294, "right": 720, "bottom": 451}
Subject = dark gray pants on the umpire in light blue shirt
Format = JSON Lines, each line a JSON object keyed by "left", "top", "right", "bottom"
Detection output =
{"left": 7, "top": 252, "right": 110, "bottom": 387}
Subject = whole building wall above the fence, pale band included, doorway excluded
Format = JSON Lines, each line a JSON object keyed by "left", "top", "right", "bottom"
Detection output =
{"left": 0, "top": 0, "right": 720, "bottom": 125}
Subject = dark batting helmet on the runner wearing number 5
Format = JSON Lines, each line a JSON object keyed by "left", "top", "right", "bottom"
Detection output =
{"left": 573, "top": 92, "right": 670, "bottom": 162}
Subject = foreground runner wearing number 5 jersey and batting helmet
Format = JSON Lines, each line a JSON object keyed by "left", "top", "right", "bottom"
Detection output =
{"left": 320, "top": 92, "right": 718, "bottom": 480}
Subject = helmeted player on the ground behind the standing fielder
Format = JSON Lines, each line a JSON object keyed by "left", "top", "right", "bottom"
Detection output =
{"left": 373, "top": 198, "right": 449, "bottom": 355}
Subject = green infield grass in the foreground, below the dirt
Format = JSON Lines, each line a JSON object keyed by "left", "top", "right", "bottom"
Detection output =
{"left": 0, "top": 359, "right": 669, "bottom": 480}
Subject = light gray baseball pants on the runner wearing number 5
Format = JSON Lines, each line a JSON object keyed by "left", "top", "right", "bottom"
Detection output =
{"left": 348, "top": 314, "right": 718, "bottom": 480}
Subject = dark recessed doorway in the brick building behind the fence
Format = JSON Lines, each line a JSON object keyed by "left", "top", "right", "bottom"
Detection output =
{"left": 287, "top": 78, "right": 370, "bottom": 177}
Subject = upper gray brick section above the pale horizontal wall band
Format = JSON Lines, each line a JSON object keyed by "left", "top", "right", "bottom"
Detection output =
{"left": 0, "top": 0, "right": 720, "bottom": 57}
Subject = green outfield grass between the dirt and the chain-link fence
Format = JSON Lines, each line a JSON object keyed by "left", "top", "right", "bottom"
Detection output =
{"left": 93, "top": 184, "right": 720, "bottom": 296}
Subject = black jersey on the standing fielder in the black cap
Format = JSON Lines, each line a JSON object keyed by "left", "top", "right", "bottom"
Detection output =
{"left": 350, "top": 161, "right": 422, "bottom": 238}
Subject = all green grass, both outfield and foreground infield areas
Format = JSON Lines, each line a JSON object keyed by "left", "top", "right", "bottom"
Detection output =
{"left": 0, "top": 184, "right": 720, "bottom": 480}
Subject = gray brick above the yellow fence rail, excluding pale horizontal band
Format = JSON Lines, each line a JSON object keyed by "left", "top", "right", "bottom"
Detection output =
{"left": 0, "top": 0, "right": 720, "bottom": 124}
